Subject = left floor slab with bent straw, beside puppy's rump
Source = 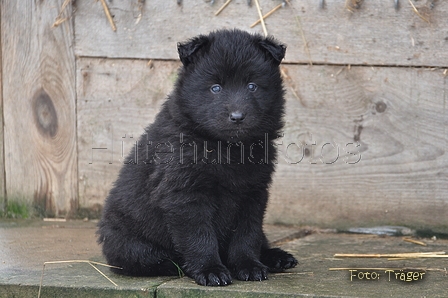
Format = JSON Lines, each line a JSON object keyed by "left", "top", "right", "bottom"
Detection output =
{"left": 0, "top": 221, "right": 172, "bottom": 298}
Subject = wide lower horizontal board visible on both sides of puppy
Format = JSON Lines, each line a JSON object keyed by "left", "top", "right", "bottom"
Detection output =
{"left": 77, "top": 58, "right": 448, "bottom": 229}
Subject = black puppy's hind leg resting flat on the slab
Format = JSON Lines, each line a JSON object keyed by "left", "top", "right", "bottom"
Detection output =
{"left": 100, "top": 236, "right": 180, "bottom": 276}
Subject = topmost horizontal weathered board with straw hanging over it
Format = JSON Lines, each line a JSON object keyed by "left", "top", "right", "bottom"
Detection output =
{"left": 75, "top": 0, "right": 448, "bottom": 67}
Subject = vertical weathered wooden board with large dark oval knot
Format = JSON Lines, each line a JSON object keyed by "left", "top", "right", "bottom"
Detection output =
{"left": 1, "top": 0, "right": 78, "bottom": 216}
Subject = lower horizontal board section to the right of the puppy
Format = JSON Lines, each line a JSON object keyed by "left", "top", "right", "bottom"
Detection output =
{"left": 266, "top": 66, "right": 448, "bottom": 231}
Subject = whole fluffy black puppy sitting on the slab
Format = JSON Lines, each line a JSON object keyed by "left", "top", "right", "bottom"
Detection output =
{"left": 98, "top": 30, "right": 297, "bottom": 286}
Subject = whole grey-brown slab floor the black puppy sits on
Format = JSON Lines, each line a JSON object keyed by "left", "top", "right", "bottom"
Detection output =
{"left": 0, "top": 221, "right": 448, "bottom": 298}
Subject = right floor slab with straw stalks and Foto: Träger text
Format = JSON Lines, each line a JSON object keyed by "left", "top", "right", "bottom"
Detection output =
{"left": 157, "top": 233, "right": 448, "bottom": 297}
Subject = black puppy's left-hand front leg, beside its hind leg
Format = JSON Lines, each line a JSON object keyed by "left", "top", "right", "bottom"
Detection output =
{"left": 167, "top": 203, "right": 232, "bottom": 286}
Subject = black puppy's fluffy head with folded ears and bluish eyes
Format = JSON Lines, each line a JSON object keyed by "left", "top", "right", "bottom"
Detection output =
{"left": 175, "top": 30, "right": 286, "bottom": 140}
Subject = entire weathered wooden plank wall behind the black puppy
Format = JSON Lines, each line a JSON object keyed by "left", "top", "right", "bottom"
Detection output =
{"left": 1, "top": 0, "right": 448, "bottom": 232}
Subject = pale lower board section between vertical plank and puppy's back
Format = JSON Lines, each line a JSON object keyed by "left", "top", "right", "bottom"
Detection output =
{"left": 77, "top": 58, "right": 179, "bottom": 208}
